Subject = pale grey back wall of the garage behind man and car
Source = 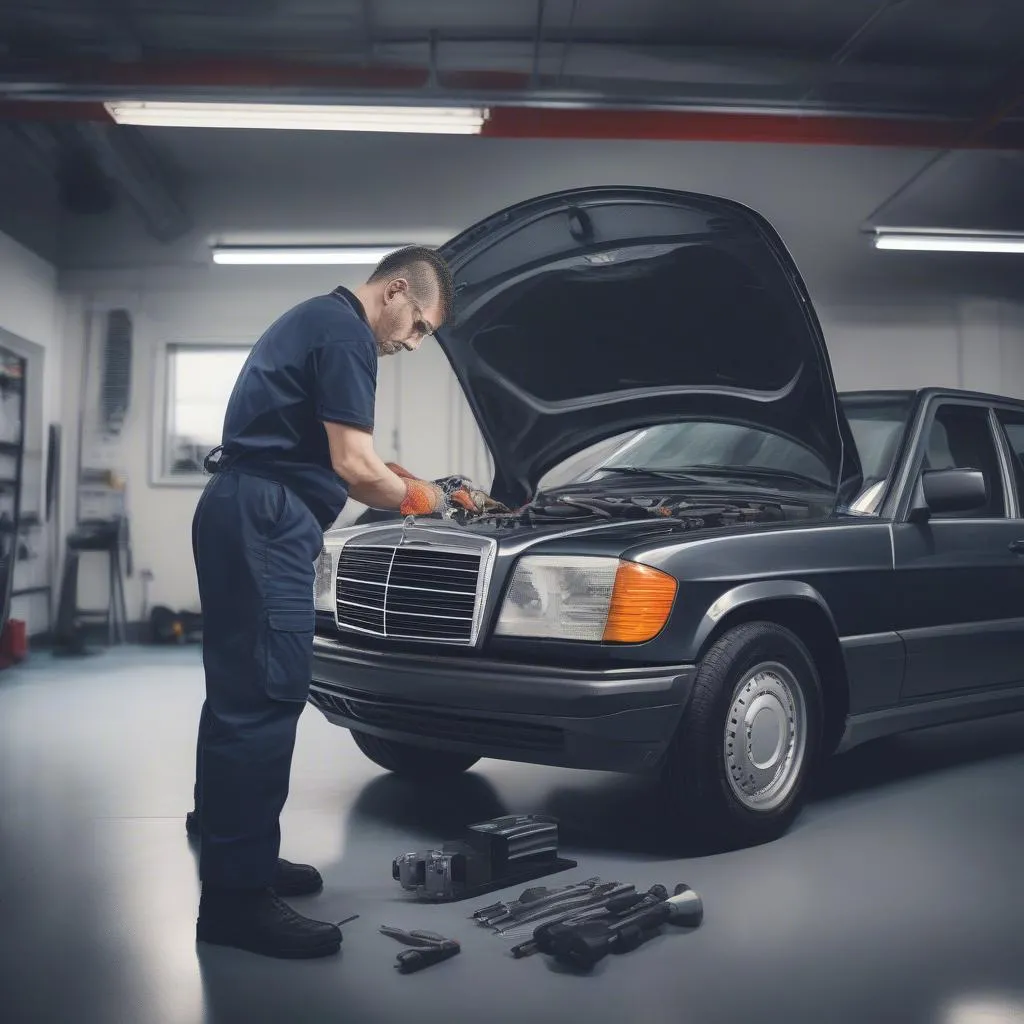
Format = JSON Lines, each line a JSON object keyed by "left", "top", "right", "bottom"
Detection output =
{"left": 56, "top": 132, "right": 1024, "bottom": 615}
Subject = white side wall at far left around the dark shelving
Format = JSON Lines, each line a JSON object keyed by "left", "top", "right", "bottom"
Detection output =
{"left": 0, "top": 233, "right": 66, "bottom": 633}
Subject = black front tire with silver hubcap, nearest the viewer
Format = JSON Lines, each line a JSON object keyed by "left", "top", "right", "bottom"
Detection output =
{"left": 662, "top": 622, "right": 822, "bottom": 851}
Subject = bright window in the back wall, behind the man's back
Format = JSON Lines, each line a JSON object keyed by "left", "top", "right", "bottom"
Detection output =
{"left": 154, "top": 344, "right": 250, "bottom": 483}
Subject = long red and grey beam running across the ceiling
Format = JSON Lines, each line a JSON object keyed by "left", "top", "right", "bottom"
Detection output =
{"left": 0, "top": 58, "right": 1024, "bottom": 151}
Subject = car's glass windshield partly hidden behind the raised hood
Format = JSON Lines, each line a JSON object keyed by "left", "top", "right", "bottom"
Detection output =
{"left": 545, "top": 392, "right": 911, "bottom": 503}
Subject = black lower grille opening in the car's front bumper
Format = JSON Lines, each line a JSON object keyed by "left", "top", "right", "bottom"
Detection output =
{"left": 309, "top": 689, "right": 565, "bottom": 751}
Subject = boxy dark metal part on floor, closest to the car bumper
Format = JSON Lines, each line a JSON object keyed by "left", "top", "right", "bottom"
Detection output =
{"left": 391, "top": 814, "right": 577, "bottom": 902}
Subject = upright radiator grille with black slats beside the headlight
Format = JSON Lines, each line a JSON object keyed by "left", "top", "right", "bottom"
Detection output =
{"left": 337, "top": 545, "right": 481, "bottom": 644}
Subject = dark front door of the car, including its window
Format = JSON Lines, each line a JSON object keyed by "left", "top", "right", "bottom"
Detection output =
{"left": 893, "top": 396, "right": 1024, "bottom": 699}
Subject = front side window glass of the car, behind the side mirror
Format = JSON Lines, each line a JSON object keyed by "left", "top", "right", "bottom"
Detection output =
{"left": 922, "top": 402, "right": 1006, "bottom": 519}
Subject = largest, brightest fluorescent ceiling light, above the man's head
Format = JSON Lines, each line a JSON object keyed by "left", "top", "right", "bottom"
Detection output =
{"left": 103, "top": 99, "right": 488, "bottom": 135}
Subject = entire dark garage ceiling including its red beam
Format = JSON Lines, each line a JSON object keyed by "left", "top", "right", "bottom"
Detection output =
{"left": 0, "top": 0, "right": 1024, "bottom": 253}
